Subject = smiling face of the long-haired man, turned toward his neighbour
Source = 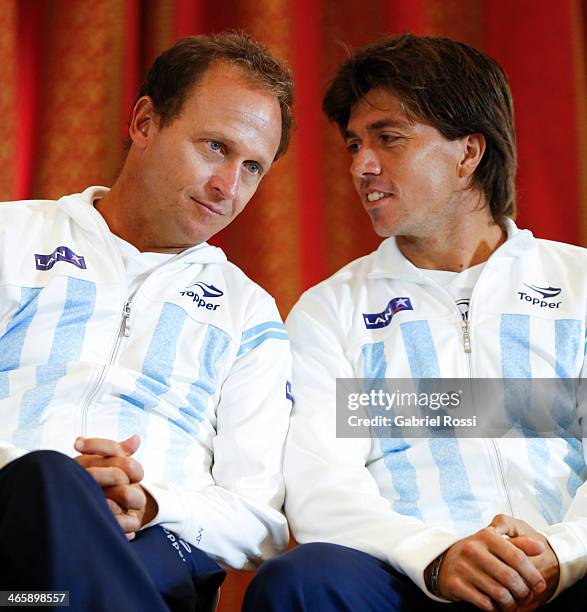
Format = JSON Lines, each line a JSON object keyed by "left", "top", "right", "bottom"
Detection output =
{"left": 346, "top": 89, "right": 470, "bottom": 237}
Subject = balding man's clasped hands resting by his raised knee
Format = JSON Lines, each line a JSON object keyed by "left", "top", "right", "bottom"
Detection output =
{"left": 74, "top": 435, "right": 146, "bottom": 539}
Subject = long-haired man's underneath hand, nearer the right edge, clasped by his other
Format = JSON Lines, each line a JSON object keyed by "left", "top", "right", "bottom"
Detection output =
{"left": 491, "top": 514, "right": 560, "bottom": 612}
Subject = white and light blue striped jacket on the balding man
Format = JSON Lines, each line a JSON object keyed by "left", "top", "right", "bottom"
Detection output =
{"left": 0, "top": 188, "right": 291, "bottom": 568}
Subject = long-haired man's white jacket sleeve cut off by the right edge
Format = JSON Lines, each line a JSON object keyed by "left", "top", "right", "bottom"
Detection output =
{"left": 541, "top": 334, "right": 587, "bottom": 598}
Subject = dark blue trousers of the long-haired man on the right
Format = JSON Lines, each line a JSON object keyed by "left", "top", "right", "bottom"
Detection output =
{"left": 243, "top": 542, "right": 587, "bottom": 612}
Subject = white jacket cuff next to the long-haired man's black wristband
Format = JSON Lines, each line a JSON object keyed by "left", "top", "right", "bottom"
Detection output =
{"left": 390, "top": 527, "right": 461, "bottom": 603}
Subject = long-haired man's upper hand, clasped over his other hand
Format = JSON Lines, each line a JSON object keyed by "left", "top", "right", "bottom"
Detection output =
{"left": 427, "top": 526, "right": 546, "bottom": 610}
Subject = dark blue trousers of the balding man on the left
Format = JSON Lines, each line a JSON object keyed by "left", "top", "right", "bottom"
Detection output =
{"left": 0, "top": 451, "right": 225, "bottom": 612}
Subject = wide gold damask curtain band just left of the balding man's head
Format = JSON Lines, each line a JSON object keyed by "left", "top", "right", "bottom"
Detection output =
{"left": 33, "top": 0, "right": 122, "bottom": 198}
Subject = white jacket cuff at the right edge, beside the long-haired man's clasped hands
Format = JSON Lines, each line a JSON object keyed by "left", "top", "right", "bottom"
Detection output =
{"left": 540, "top": 523, "right": 587, "bottom": 601}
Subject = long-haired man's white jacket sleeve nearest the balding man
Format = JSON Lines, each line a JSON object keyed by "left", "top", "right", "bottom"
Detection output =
{"left": 284, "top": 291, "right": 459, "bottom": 599}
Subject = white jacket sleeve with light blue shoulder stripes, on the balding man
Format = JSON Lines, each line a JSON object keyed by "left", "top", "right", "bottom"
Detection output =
{"left": 144, "top": 298, "right": 291, "bottom": 569}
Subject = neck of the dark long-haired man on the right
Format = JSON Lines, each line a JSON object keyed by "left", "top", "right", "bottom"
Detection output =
{"left": 396, "top": 208, "right": 507, "bottom": 272}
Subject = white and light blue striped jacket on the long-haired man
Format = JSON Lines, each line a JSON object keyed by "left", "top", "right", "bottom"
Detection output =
{"left": 284, "top": 223, "right": 587, "bottom": 591}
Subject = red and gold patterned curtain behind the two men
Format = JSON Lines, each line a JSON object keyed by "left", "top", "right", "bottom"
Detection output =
{"left": 0, "top": 0, "right": 587, "bottom": 612}
